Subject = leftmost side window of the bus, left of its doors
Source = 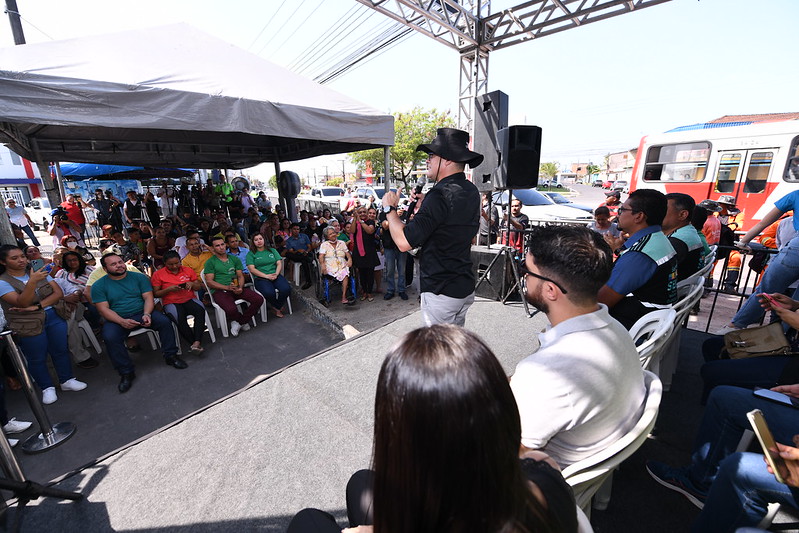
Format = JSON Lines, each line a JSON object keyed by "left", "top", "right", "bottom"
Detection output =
{"left": 644, "top": 142, "right": 710, "bottom": 181}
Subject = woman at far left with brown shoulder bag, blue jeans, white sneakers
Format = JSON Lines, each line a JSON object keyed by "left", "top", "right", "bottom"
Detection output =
{"left": 0, "top": 245, "right": 86, "bottom": 404}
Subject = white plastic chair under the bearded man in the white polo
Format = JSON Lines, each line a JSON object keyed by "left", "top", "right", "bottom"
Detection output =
{"left": 563, "top": 370, "right": 663, "bottom": 518}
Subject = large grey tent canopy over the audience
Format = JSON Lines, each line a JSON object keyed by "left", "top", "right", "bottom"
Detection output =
{"left": 0, "top": 24, "right": 394, "bottom": 168}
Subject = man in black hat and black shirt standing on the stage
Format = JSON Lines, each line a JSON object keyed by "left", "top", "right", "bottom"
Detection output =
{"left": 383, "top": 128, "right": 483, "bottom": 326}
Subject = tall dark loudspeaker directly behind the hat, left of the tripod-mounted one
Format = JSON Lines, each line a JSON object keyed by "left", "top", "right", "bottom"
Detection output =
{"left": 472, "top": 91, "right": 508, "bottom": 192}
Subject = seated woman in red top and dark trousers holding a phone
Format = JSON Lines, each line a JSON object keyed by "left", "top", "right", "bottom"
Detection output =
{"left": 150, "top": 250, "right": 205, "bottom": 354}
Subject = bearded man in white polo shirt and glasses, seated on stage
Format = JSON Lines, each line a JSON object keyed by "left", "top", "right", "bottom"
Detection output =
{"left": 510, "top": 226, "right": 646, "bottom": 468}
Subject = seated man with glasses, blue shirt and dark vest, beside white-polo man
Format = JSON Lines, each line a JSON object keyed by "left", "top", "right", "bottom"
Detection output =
{"left": 598, "top": 189, "right": 677, "bottom": 329}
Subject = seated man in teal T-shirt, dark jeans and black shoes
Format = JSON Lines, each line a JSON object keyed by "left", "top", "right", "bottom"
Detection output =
{"left": 91, "top": 253, "right": 188, "bottom": 392}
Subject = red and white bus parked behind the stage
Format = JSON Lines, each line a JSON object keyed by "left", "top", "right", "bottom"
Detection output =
{"left": 630, "top": 120, "right": 799, "bottom": 231}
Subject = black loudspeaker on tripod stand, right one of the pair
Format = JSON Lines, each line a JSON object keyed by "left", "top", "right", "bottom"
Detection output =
{"left": 494, "top": 126, "right": 541, "bottom": 189}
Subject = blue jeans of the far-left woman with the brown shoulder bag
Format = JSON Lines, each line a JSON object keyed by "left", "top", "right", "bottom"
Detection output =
{"left": 17, "top": 308, "right": 74, "bottom": 390}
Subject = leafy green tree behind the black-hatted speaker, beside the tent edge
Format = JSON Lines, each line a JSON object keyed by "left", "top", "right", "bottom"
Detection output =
{"left": 349, "top": 106, "right": 455, "bottom": 191}
